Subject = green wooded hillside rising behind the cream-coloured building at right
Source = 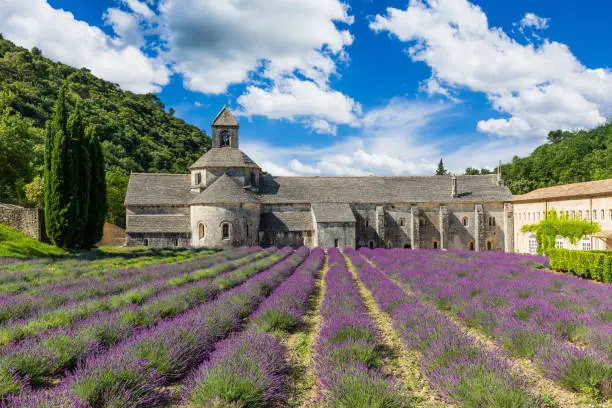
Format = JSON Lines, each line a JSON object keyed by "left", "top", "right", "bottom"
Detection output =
{"left": 502, "top": 123, "right": 612, "bottom": 194}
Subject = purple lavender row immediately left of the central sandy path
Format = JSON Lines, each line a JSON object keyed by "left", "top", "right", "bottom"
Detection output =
{"left": 183, "top": 249, "right": 325, "bottom": 407}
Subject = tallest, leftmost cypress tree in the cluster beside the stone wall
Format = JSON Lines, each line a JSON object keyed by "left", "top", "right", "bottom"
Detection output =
{"left": 44, "top": 87, "right": 68, "bottom": 246}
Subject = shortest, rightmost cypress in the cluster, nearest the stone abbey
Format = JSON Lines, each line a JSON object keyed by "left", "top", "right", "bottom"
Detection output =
{"left": 83, "top": 126, "right": 107, "bottom": 248}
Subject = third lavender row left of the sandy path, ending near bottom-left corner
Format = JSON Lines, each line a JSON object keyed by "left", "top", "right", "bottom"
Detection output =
{"left": 0, "top": 248, "right": 292, "bottom": 396}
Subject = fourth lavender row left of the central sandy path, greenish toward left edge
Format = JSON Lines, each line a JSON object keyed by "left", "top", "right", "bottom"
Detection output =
{"left": 0, "top": 250, "right": 275, "bottom": 346}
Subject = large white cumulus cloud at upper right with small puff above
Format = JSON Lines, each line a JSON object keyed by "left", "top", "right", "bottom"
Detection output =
{"left": 370, "top": 0, "right": 612, "bottom": 137}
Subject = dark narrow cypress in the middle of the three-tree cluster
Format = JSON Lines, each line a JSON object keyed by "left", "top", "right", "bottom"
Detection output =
{"left": 68, "top": 105, "right": 91, "bottom": 248}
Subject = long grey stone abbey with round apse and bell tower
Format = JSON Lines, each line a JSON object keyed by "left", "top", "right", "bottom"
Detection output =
{"left": 125, "top": 108, "right": 515, "bottom": 252}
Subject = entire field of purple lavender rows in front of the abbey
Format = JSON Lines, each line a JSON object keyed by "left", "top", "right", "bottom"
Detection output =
{"left": 0, "top": 247, "right": 612, "bottom": 408}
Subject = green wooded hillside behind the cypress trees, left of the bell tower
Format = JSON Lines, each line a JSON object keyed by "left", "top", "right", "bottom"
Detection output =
{"left": 0, "top": 36, "right": 210, "bottom": 225}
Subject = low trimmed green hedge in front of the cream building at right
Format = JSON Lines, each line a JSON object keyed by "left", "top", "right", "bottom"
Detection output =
{"left": 546, "top": 249, "right": 612, "bottom": 282}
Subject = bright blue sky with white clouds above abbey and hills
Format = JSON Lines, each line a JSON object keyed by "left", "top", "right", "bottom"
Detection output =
{"left": 0, "top": 0, "right": 612, "bottom": 175}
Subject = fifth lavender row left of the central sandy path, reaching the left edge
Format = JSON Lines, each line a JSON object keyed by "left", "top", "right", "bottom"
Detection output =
{"left": 0, "top": 248, "right": 258, "bottom": 323}
